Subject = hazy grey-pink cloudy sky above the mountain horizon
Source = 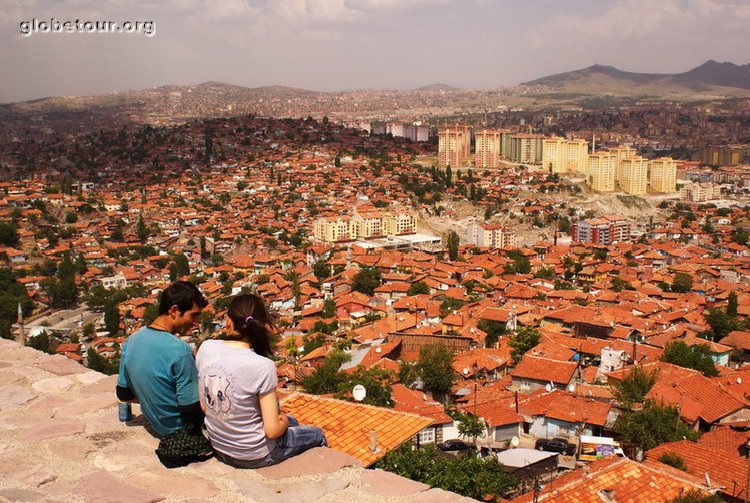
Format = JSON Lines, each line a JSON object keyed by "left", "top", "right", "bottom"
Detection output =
{"left": 0, "top": 0, "right": 750, "bottom": 102}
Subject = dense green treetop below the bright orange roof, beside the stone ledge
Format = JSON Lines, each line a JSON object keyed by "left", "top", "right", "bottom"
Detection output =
{"left": 375, "top": 444, "right": 518, "bottom": 502}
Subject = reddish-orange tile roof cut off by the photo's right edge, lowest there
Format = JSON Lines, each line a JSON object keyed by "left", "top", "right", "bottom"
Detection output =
{"left": 646, "top": 440, "right": 748, "bottom": 499}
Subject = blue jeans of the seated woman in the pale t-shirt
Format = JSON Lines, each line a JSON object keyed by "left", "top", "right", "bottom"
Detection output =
{"left": 215, "top": 416, "right": 328, "bottom": 468}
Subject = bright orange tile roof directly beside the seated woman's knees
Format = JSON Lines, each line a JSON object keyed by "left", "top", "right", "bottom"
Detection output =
{"left": 281, "top": 393, "right": 433, "bottom": 466}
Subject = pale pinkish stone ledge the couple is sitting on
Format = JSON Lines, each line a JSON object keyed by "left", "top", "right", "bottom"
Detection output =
{"left": 0, "top": 339, "right": 482, "bottom": 503}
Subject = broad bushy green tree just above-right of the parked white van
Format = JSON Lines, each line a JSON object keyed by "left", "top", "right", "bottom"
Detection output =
{"left": 614, "top": 400, "right": 700, "bottom": 451}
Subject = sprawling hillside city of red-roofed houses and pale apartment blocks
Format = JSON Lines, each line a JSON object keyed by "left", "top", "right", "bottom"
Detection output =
{"left": 0, "top": 90, "right": 750, "bottom": 503}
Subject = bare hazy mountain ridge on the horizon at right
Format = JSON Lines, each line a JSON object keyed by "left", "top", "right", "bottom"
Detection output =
{"left": 522, "top": 60, "right": 750, "bottom": 95}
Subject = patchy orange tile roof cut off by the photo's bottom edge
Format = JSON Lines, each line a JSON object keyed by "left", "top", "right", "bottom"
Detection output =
{"left": 510, "top": 456, "right": 709, "bottom": 503}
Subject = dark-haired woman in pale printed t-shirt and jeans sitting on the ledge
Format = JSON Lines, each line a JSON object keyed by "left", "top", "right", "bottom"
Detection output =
{"left": 196, "top": 294, "right": 328, "bottom": 468}
